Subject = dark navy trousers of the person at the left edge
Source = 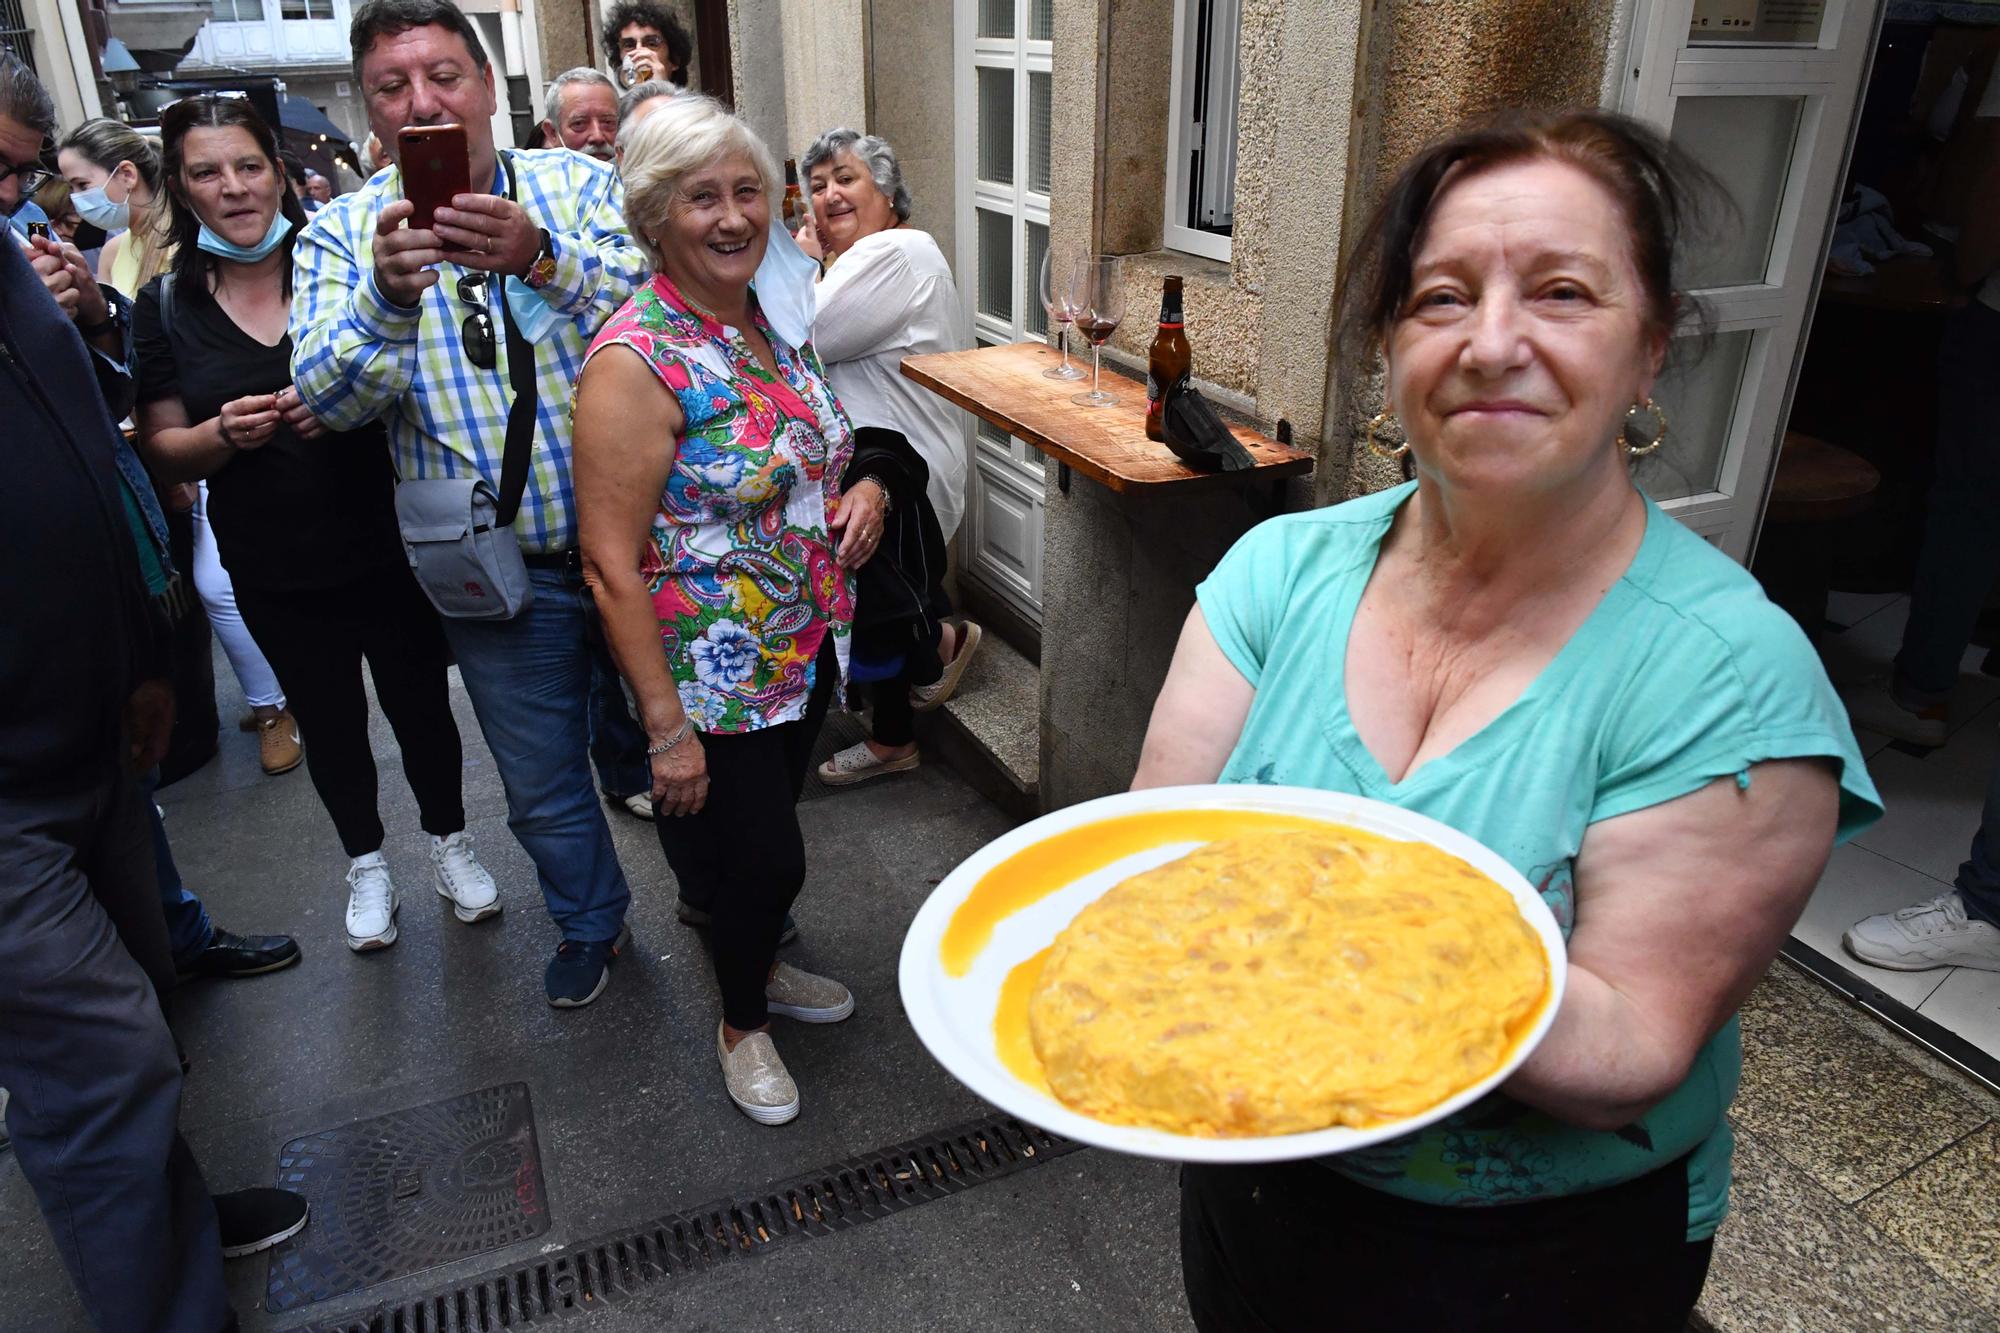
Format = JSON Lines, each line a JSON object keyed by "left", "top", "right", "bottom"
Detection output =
{"left": 0, "top": 765, "right": 230, "bottom": 1333}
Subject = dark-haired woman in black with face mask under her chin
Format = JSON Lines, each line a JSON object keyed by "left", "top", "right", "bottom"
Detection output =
{"left": 134, "top": 96, "right": 500, "bottom": 951}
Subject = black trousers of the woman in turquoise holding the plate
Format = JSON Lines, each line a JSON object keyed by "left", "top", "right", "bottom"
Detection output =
{"left": 1180, "top": 1159, "right": 1710, "bottom": 1333}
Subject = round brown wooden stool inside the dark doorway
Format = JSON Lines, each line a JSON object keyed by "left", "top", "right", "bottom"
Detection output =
{"left": 1750, "top": 430, "right": 1882, "bottom": 642}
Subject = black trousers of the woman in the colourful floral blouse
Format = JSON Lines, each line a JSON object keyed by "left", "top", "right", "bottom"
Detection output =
{"left": 652, "top": 636, "right": 840, "bottom": 1031}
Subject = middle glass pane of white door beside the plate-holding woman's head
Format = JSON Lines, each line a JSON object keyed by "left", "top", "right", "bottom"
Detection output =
{"left": 1674, "top": 96, "right": 1806, "bottom": 288}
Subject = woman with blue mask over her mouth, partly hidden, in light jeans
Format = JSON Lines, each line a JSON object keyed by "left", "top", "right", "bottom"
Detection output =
{"left": 56, "top": 118, "right": 302, "bottom": 775}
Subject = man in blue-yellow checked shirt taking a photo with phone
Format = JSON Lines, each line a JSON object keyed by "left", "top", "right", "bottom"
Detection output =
{"left": 292, "top": 0, "right": 646, "bottom": 1007}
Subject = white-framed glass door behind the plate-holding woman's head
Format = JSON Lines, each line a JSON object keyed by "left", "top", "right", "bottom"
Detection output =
{"left": 1618, "top": 0, "right": 1882, "bottom": 560}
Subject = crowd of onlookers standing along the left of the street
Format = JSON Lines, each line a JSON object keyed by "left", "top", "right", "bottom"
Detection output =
{"left": 0, "top": 0, "right": 980, "bottom": 1329}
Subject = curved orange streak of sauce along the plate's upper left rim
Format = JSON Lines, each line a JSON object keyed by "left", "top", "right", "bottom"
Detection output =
{"left": 938, "top": 811, "right": 1330, "bottom": 976}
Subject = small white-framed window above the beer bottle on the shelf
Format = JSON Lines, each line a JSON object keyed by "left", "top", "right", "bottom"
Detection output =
{"left": 1162, "top": 0, "right": 1242, "bottom": 264}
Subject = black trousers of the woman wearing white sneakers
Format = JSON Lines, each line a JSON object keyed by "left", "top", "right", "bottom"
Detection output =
{"left": 236, "top": 566, "right": 466, "bottom": 857}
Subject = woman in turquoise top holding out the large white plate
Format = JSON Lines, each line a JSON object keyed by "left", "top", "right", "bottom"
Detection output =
{"left": 1134, "top": 112, "right": 1880, "bottom": 1333}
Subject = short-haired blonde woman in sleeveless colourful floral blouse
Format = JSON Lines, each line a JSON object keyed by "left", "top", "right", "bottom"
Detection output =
{"left": 576, "top": 96, "right": 860, "bottom": 1125}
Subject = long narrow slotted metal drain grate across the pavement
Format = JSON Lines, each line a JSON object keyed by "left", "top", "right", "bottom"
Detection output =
{"left": 296, "top": 1117, "right": 1082, "bottom": 1333}
